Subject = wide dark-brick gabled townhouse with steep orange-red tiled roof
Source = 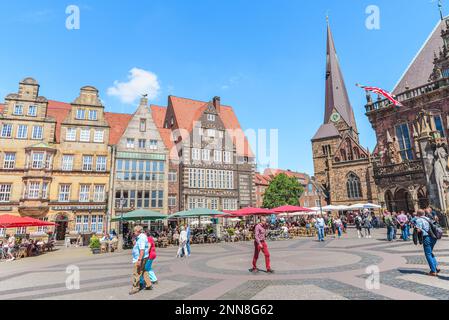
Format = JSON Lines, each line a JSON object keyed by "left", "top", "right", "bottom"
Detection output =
{"left": 152, "top": 96, "right": 255, "bottom": 210}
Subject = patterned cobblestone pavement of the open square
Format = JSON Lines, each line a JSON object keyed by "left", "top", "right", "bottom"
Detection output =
{"left": 0, "top": 230, "right": 449, "bottom": 300}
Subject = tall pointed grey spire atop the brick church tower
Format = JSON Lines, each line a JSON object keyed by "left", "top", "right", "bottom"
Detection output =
{"left": 324, "top": 17, "right": 358, "bottom": 133}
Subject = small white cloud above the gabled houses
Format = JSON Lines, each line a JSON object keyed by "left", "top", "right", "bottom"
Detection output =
{"left": 107, "top": 68, "right": 161, "bottom": 104}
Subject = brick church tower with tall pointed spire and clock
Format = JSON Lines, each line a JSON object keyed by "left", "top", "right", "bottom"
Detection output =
{"left": 312, "top": 21, "right": 377, "bottom": 205}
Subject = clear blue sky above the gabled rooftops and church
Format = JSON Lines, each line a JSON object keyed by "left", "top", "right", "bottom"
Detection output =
{"left": 0, "top": 0, "right": 442, "bottom": 173}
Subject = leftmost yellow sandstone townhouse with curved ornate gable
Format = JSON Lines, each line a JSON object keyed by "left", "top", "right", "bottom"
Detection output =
{"left": 0, "top": 78, "right": 57, "bottom": 235}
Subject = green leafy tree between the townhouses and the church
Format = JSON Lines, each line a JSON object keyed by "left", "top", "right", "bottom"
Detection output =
{"left": 263, "top": 173, "right": 304, "bottom": 209}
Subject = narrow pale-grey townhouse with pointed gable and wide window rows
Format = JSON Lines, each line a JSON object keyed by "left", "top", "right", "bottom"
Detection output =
{"left": 113, "top": 98, "right": 169, "bottom": 221}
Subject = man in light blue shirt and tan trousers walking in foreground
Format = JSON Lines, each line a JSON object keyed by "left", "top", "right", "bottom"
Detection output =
{"left": 129, "top": 226, "right": 152, "bottom": 295}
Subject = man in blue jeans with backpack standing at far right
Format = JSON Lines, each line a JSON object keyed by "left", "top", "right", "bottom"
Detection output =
{"left": 416, "top": 210, "right": 443, "bottom": 277}
